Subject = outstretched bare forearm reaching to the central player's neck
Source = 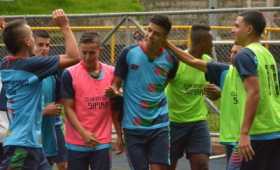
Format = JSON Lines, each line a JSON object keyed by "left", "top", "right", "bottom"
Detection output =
{"left": 167, "top": 42, "right": 207, "bottom": 72}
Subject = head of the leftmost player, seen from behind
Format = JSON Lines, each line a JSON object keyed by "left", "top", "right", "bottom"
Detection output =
{"left": 2, "top": 20, "right": 34, "bottom": 55}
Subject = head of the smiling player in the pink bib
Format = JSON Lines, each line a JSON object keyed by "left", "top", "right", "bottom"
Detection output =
{"left": 79, "top": 32, "right": 101, "bottom": 66}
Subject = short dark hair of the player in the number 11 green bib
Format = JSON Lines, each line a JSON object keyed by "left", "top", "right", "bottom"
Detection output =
{"left": 239, "top": 11, "right": 266, "bottom": 36}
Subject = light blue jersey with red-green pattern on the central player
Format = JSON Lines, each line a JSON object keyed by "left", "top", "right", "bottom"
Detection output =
{"left": 115, "top": 45, "right": 177, "bottom": 129}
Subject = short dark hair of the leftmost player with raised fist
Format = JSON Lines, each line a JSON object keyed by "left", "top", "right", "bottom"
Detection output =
{"left": 2, "top": 20, "right": 26, "bottom": 54}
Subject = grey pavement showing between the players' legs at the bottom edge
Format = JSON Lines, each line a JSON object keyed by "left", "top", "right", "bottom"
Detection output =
{"left": 112, "top": 153, "right": 226, "bottom": 170}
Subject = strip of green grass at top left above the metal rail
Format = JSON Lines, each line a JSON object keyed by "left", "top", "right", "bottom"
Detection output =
{"left": 0, "top": 0, "right": 144, "bottom": 15}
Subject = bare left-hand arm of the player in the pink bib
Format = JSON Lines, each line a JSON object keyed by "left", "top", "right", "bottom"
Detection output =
{"left": 63, "top": 99, "right": 98, "bottom": 147}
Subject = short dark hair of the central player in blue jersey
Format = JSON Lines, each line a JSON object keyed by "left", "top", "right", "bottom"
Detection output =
{"left": 150, "top": 15, "right": 172, "bottom": 34}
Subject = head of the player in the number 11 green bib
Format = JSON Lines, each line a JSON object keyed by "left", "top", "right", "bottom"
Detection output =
{"left": 232, "top": 11, "right": 266, "bottom": 46}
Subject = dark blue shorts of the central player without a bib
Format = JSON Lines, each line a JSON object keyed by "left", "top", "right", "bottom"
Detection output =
{"left": 124, "top": 127, "right": 170, "bottom": 170}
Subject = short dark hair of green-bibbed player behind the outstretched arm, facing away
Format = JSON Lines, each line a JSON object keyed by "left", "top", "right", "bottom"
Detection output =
{"left": 191, "top": 24, "right": 211, "bottom": 44}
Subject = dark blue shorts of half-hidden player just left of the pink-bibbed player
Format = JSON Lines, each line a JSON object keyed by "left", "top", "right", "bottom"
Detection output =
{"left": 47, "top": 125, "right": 67, "bottom": 164}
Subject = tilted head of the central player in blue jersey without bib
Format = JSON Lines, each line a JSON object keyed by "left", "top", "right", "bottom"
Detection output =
{"left": 145, "top": 15, "right": 172, "bottom": 48}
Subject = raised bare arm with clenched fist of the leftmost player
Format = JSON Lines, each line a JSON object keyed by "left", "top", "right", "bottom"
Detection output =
{"left": 53, "top": 9, "right": 79, "bottom": 68}
